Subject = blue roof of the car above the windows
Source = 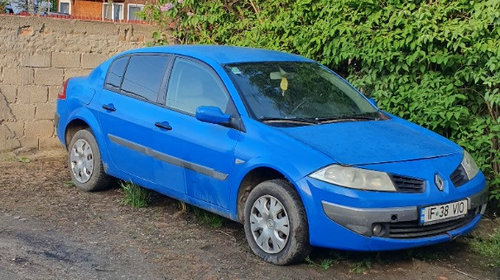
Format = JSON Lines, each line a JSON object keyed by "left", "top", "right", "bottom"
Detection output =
{"left": 126, "top": 45, "right": 313, "bottom": 64}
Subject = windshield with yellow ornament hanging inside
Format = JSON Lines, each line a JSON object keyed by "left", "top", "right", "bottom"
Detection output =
{"left": 225, "top": 62, "right": 379, "bottom": 124}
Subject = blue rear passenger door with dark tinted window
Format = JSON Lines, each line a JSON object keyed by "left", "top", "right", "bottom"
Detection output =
{"left": 97, "top": 54, "right": 185, "bottom": 194}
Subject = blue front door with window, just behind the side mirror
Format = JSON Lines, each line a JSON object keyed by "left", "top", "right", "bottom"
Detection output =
{"left": 156, "top": 57, "right": 240, "bottom": 208}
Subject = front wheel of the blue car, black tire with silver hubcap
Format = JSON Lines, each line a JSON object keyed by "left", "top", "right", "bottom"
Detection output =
{"left": 244, "top": 179, "right": 311, "bottom": 265}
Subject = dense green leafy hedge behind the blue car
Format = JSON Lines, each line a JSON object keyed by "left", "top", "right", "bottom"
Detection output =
{"left": 143, "top": 0, "right": 500, "bottom": 208}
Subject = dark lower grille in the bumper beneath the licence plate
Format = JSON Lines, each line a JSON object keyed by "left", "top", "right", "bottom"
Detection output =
{"left": 387, "top": 209, "right": 477, "bottom": 239}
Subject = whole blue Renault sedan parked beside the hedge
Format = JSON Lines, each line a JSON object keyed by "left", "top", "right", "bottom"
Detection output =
{"left": 56, "top": 46, "right": 487, "bottom": 264}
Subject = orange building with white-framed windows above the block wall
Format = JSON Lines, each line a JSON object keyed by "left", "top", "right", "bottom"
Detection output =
{"left": 58, "top": 0, "right": 149, "bottom": 21}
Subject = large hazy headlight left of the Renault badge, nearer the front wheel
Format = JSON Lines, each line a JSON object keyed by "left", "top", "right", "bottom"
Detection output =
{"left": 309, "top": 164, "right": 396, "bottom": 192}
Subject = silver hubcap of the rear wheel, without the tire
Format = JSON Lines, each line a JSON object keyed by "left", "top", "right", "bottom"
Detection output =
{"left": 70, "top": 139, "right": 94, "bottom": 184}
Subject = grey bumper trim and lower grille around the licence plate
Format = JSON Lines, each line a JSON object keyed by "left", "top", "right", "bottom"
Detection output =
{"left": 321, "top": 189, "right": 488, "bottom": 238}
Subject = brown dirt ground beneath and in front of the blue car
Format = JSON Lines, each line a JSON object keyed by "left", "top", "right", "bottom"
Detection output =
{"left": 0, "top": 152, "right": 500, "bottom": 280}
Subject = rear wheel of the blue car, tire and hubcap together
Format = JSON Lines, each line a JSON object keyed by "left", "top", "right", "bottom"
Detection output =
{"left": 68, "top": 129, "right": 111, "bottom": 192}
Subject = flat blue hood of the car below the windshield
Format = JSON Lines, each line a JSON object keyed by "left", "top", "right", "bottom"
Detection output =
{"left": 279, "top": 117, "right": 461, "bottom": 165}
